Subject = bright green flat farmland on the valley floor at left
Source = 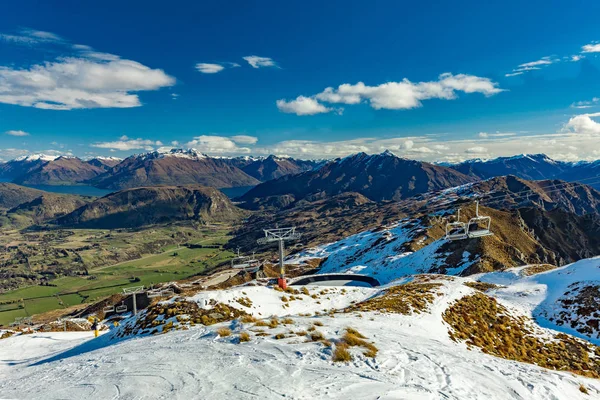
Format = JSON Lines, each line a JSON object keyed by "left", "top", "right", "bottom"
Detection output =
{"left": 0, "top": 229, "right": 233, "bottom": 325}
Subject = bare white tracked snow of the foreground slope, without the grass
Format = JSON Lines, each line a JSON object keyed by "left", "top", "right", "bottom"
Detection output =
{"left": 0, "top": 278, "right": 600, "bottom": 400}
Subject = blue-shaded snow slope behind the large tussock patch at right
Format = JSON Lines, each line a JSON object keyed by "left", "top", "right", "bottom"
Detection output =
{"left": 477, "top": 257, "right": 600, "bottom": 345}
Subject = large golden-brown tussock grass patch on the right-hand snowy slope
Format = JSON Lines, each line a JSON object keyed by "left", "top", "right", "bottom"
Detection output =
{"left": 443, "top": 293, "right": 600, "bottom": 378}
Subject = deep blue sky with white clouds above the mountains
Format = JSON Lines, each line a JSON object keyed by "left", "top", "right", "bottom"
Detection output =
{"left": 0, "top": 1, "right": 600, "bottom": 161}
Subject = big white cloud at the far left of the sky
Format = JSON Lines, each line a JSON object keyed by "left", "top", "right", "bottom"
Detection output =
{"left": 0, "top": 31, "right": 175, "bottom": 110}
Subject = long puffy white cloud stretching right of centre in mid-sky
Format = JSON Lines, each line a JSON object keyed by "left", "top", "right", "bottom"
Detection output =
{"left": 277, "top": 73, "right": 504, "bottom": 115}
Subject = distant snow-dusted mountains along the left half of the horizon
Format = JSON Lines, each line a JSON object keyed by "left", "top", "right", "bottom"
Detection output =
{"left": 0, "top": 149, "right": 319, "bottom": 190}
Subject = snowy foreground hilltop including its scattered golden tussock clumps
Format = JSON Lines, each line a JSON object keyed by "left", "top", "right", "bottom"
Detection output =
{"left": 0, "top": 270, "right": 600, "bottom": 399}
